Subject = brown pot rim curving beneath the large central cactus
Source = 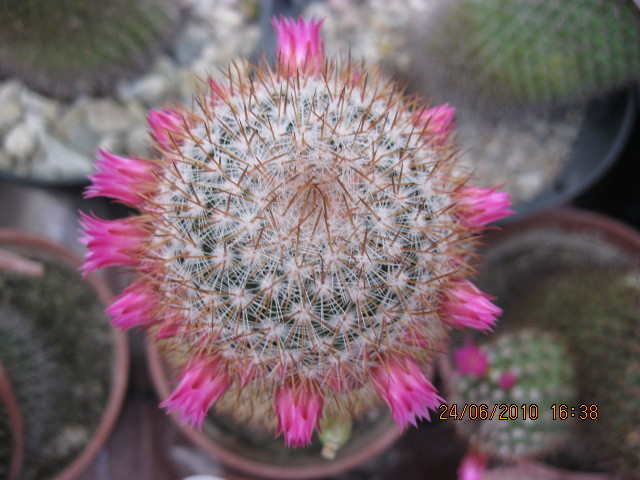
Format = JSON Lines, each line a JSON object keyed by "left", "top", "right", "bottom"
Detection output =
{"left": 147, "top": 339, "right": 401, "bottom": 479}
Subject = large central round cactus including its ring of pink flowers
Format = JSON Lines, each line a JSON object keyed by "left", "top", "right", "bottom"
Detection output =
{"left": 82, "top": 19, "right": 509, "bottom": 446}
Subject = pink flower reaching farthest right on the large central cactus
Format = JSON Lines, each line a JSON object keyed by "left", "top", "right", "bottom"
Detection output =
{"left": 457, "top": 185, "right": 513, "bottom": 228}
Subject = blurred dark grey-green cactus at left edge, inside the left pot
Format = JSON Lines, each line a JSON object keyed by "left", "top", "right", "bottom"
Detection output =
{"left": 0, "top": 305, "right": 59, "bottom": 479}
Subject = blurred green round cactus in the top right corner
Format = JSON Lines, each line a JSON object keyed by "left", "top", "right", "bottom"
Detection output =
{"left": 421, "top": 0, "right": 640, "bottom": 109}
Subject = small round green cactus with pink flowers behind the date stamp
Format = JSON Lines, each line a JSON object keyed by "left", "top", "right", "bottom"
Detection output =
{"left": 450, "top": 328, "right": 576, "bottom": 459}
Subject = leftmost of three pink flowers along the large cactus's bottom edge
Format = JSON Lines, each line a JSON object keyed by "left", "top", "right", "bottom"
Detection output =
{"left": 160, "top": 357, "right": 231, "bottom": 430}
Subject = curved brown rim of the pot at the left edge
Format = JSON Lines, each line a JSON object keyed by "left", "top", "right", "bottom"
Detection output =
{"left": 0, "top": 228, "right": 129, "bottom": 480}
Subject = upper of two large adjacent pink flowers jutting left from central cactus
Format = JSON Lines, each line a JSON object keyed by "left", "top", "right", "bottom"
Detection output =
{"left": 84, "top": 150, "right": 154, "bottom": 207}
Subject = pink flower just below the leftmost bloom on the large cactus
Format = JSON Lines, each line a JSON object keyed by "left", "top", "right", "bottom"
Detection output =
{"left": 106, "top": 281, "right": 157, "bottom": 330}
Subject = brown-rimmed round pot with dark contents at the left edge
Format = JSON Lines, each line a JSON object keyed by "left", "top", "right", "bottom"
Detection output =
{"left": 0, "top": 229, "right": 129, "bottom": 480}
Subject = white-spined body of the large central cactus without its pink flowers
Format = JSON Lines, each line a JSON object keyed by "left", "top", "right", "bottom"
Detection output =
{"left": 152, "top": 72, "right": 468, "bottom": 378}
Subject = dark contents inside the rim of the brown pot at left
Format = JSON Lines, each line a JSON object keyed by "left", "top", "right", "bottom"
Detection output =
{"left": 0, "top": 253, "right": 114, "bottom": 480}
